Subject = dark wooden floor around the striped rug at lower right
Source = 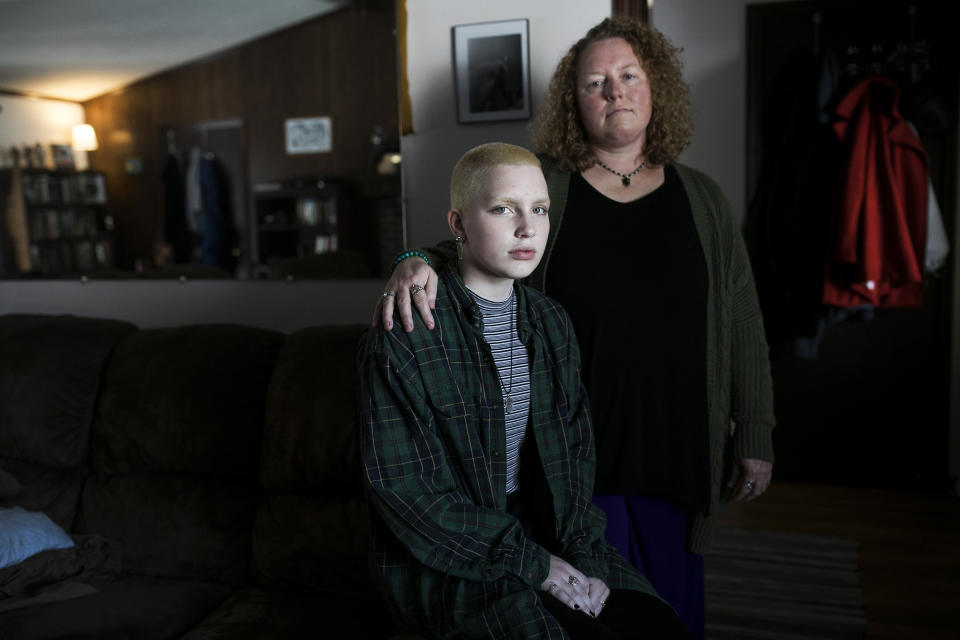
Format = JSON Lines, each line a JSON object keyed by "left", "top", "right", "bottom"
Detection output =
{"left": 720, "top": 483, "right": 960, "bottom": 640}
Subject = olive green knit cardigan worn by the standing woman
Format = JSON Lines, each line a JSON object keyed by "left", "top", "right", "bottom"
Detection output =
{"left": 526, "top": 158, "right": 774, "bottom": 553}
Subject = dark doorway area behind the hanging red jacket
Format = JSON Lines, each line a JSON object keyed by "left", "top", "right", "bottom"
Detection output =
{"left": 745, "top": 0, "right": 960, "bottom": 488}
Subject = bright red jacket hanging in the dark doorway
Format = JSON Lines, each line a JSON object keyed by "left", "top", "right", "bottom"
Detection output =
{"left": 823, "top": 76, "right": 929, "bottom": 307}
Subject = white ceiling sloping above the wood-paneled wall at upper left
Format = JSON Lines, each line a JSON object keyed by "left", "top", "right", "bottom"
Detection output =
{"left": 0, "top": 0, "right": 349, "bottom": 102}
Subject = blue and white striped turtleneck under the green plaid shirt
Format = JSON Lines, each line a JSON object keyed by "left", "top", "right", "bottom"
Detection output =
{"left": 470, "top": 289, "right": 530, "bottom": 494}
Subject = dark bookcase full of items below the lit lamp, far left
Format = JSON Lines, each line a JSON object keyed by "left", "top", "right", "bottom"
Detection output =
{"left": 0, "top": 169, "right": 113, "bottom": 275}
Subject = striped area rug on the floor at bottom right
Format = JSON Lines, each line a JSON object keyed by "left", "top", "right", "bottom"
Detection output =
{"left": 705, "top": 528, "right": 867, "bottom": 640}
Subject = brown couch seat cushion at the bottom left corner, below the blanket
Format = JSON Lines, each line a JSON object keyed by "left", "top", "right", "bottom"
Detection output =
{"left": 0, "top": 577, "right": 230, "bottom": 640}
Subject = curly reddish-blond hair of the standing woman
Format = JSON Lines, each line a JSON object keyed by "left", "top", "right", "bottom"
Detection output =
{"left": 531, "top": 16, "right": 693, "bottom": 171}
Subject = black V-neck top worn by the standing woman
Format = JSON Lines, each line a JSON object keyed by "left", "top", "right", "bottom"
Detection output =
{"left": 546, "top": 166, "right": 710, "bottom": 512}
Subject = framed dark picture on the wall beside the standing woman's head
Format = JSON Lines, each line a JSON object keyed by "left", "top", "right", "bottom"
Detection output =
{"left": 453, "top": 19, "right": 530, "bottom": 122}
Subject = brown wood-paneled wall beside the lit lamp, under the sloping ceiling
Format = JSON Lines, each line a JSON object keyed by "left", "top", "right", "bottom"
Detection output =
{"left": 84, "top": 2, "right": 400, "bottom": 268}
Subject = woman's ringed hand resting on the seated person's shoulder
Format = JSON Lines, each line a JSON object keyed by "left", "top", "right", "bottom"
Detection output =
{"left": 372, "top": 258, "right": 437, "bottom": 332}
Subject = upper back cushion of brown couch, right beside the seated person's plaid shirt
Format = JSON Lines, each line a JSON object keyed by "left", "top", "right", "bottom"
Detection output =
{"left": 261, "top": 325, "right": 365, "bottom": 495}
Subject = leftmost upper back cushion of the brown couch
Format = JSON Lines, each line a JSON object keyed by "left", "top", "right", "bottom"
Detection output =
{"left": 0, "top": 314, "right": 136, "bottom": 470}
